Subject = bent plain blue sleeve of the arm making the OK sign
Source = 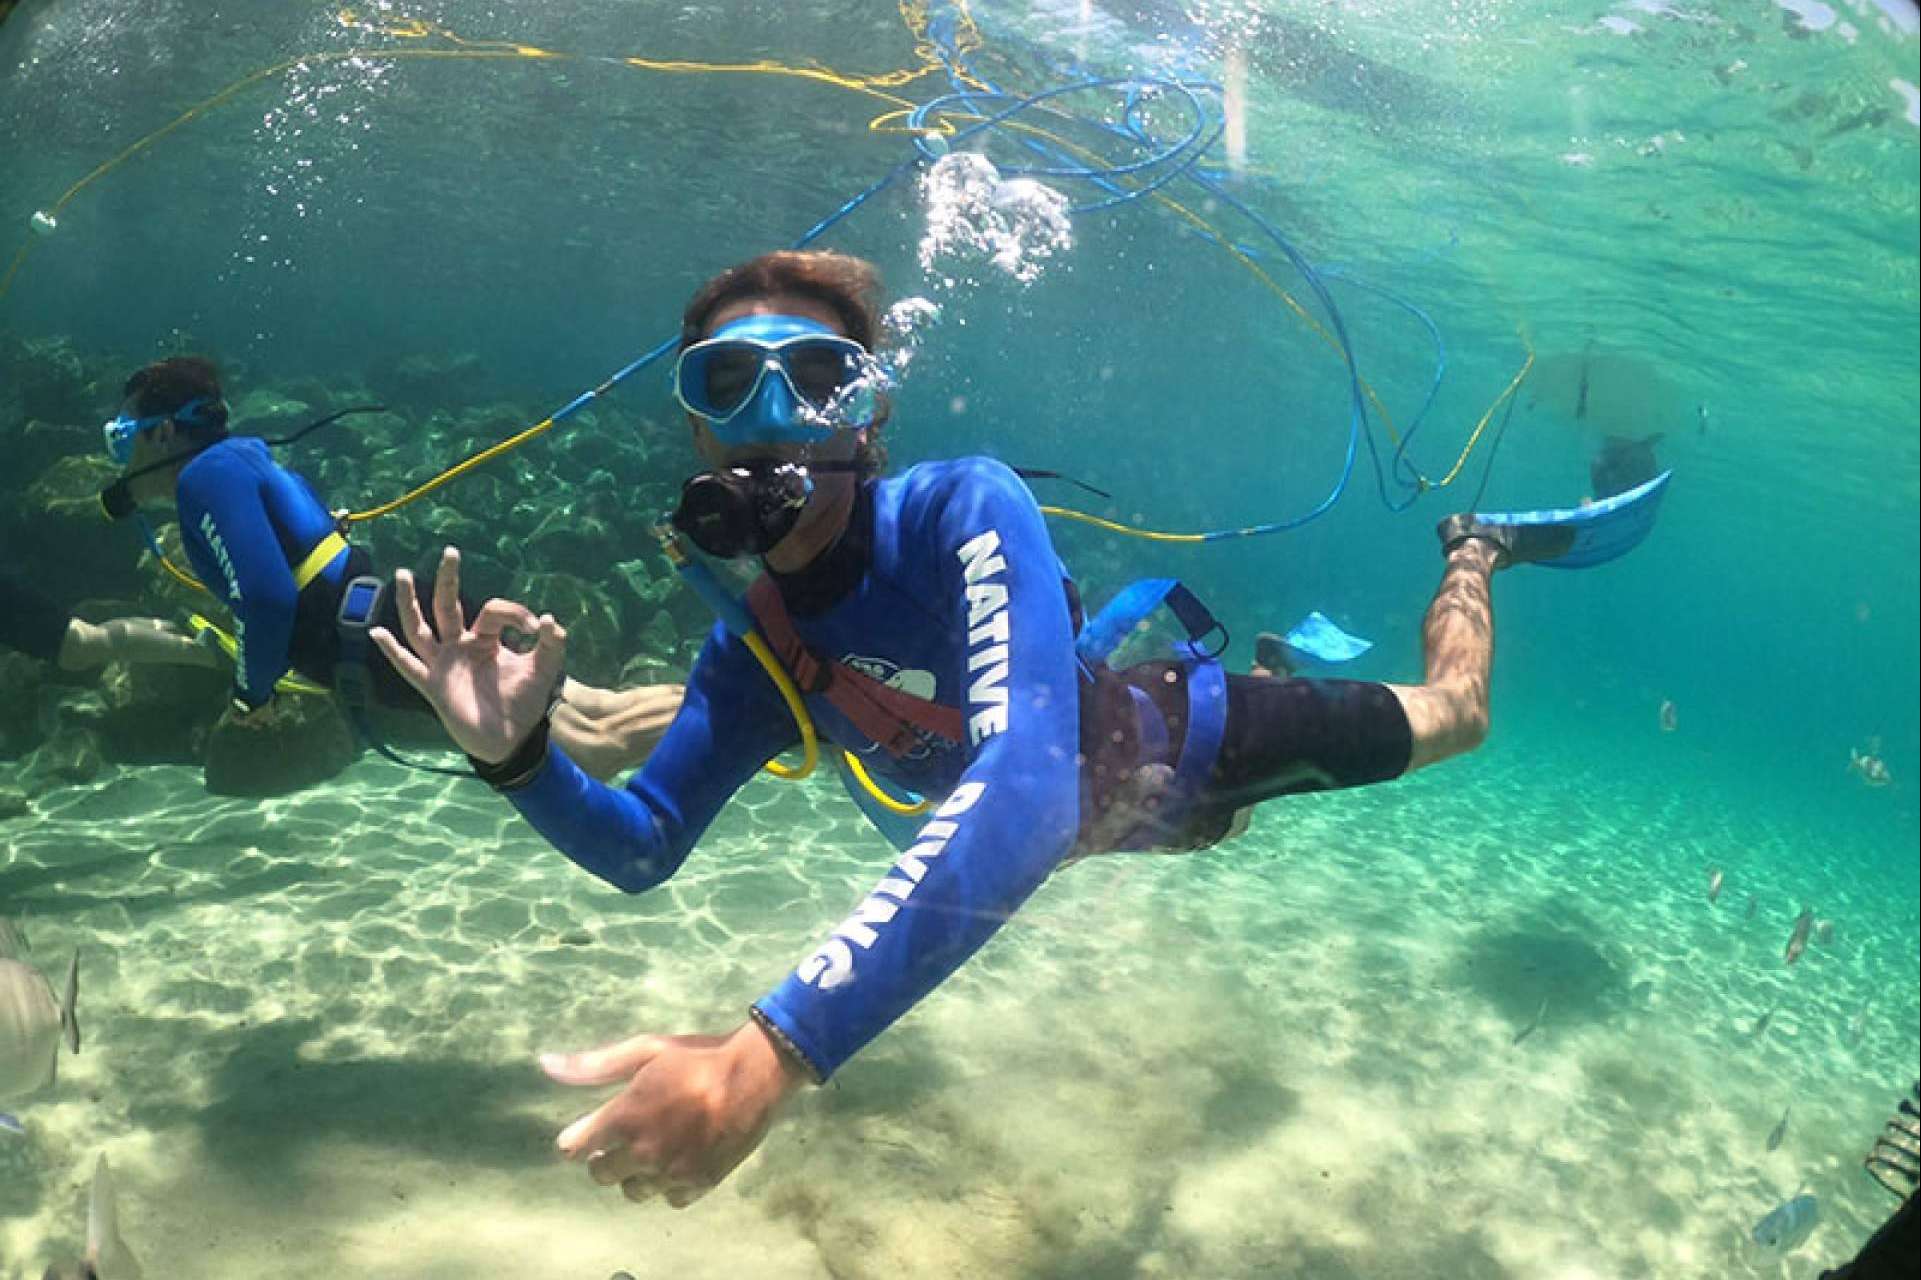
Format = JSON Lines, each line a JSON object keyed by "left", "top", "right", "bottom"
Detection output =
{"left": 507, "top": 627, "right": 799, "bottom": 894}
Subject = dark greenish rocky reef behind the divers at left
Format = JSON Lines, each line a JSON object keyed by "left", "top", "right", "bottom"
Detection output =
{"left": 0, "top": 334, "right": 711, "bottom": 803}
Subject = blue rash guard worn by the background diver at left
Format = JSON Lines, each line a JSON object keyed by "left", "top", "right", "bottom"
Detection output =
{"left": 175, "top": 436, "right": 348, "bottom": 707}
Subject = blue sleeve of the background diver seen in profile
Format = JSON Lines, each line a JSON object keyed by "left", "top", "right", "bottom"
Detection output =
{"left": 175, "top": 450, "right": 300, "bottom": 707}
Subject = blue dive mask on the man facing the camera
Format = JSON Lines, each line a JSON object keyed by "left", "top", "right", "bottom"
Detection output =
{"left": 674, "top": 315, "right": 878, "bottom": 448}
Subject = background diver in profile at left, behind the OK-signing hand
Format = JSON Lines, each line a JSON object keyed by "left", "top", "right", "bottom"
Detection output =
{"left": 100, "top": 356, "right": 680, "bottom": 776}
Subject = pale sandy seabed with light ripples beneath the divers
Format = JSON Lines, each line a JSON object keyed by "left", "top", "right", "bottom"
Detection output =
{"left": 0, "top": 738, "right": 1921, "bottom": 1280}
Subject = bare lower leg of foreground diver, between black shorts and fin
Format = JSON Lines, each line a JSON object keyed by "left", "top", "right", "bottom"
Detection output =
{"left": 1387, "top": 538, "right": 1498, "bottom": 773}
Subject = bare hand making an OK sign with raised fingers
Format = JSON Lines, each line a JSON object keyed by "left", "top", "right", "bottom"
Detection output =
{"left": 369, "top": 546, "right": 567, "bottom": 763}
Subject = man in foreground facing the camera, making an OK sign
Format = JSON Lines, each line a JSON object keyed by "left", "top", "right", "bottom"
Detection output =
{"left": 373, "top": 252, "right": 1535, "bottom": 1207}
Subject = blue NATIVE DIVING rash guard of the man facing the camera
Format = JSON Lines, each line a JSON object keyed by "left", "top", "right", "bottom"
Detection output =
{"left": 509, "top": 457, "right": 1080, "bottom": 1080}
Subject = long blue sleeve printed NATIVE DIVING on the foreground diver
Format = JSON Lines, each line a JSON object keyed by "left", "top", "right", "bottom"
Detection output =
{"left": 755, "top": 459, "right": 1080, "bottom": 1080}
